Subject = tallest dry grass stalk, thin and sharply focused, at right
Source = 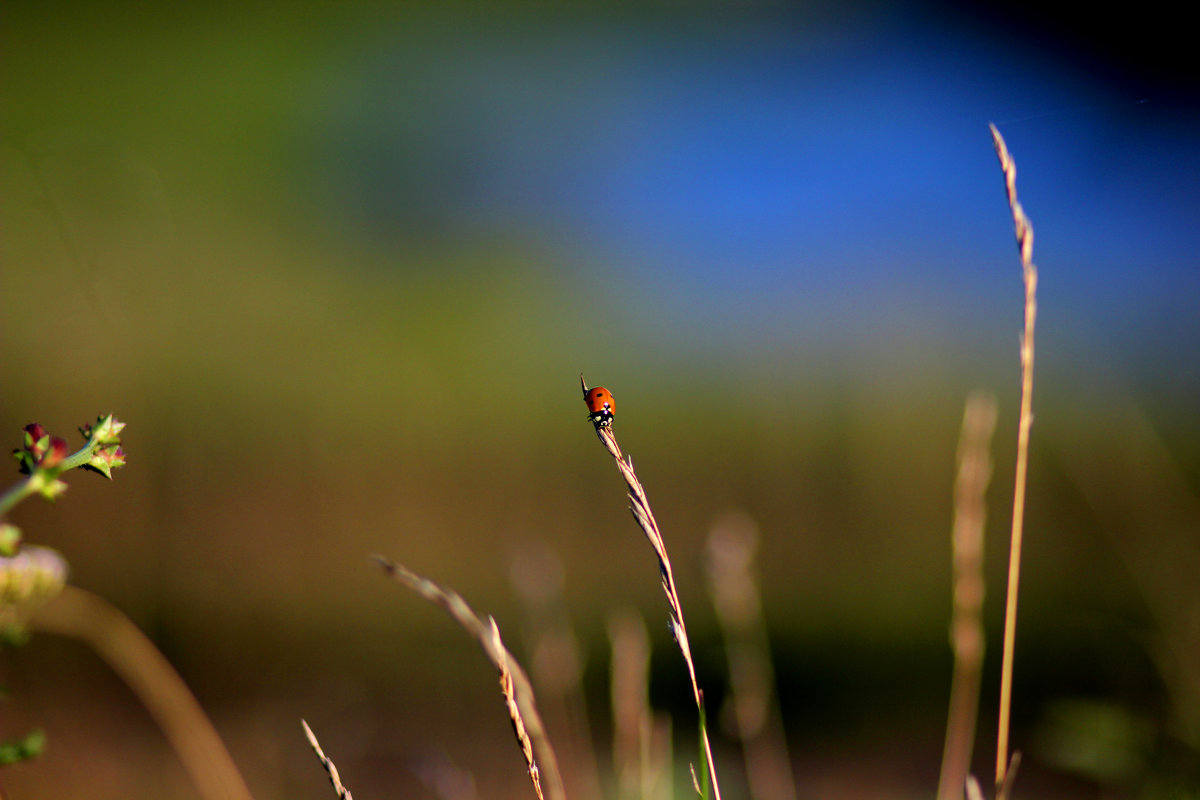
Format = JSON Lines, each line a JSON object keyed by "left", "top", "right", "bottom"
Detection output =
{"left": 989, "top": 125, "right": 1038, "bottom": 800}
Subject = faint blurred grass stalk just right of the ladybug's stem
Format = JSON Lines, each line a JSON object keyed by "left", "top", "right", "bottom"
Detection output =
{"left": 707, "top": 513, "right": 796, "bottom": 800}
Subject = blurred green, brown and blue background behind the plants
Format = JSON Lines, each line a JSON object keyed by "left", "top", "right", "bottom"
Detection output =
{"left": 0, "top": 1, "right": 1200, "bottom": 800}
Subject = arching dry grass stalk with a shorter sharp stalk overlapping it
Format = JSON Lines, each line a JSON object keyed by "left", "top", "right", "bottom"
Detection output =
{"left": 373, "top": 555, "right": 565, "bottom": 800}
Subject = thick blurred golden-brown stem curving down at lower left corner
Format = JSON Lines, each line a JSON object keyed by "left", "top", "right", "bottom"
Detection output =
{"left": 32, "top": 585, "right": 252, "bottom": 800}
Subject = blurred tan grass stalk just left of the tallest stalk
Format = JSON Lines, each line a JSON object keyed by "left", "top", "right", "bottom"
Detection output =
{"left": 937, "top": 392, "right": 996, "bottom": 800}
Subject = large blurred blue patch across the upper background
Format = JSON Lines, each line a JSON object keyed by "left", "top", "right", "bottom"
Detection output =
{"left": 312, "top": 7, "right": 1200, "bottom": 364}
